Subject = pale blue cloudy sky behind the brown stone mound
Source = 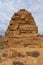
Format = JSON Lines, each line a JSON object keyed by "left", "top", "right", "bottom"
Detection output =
{"left": 0, "top": 0, "right": 43, "bottom": 35}
